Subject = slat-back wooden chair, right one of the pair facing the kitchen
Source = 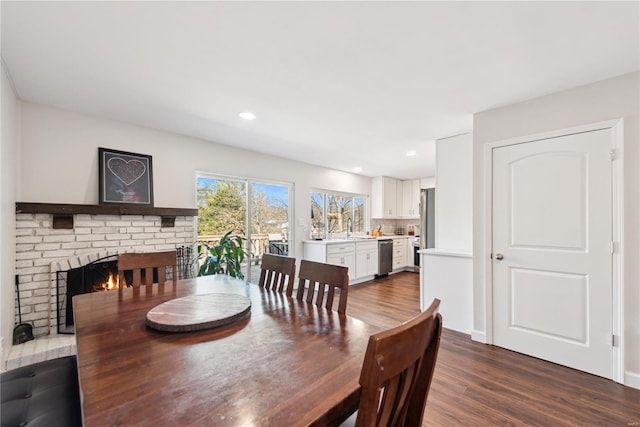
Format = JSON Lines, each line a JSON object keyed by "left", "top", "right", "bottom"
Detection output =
{"left": 296, "top": 259, "right": 349, "bottom": 314}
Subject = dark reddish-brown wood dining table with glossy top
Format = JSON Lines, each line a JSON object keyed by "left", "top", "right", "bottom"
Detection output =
{"left": 73, "top": 275, "right": 379, "bottom": 427}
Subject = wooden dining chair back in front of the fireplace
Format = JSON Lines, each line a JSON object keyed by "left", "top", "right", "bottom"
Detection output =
{"left": 118, "top": 251, "right": 178, "bottom": 287}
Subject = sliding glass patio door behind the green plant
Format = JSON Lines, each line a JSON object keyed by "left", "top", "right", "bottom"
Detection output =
{"left": 196, "top": 174, "right": 293, "bottom": 280}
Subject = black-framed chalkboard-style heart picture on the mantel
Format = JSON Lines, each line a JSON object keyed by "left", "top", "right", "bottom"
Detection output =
{"left": 98, "top": 147, "right": 153, "bottom": 207}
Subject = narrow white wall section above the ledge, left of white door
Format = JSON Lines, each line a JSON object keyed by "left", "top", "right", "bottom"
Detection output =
{"left": 435, "top": 133, "right": 473, "bottom": 253}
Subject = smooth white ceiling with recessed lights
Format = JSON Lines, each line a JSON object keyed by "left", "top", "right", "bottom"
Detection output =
{"left": 1, "top": 1, "right": 640, "bottom": 179}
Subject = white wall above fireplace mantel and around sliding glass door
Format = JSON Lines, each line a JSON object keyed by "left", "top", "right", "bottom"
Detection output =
{"left": 18, "top": 102, "right": 371, "bottom": 264}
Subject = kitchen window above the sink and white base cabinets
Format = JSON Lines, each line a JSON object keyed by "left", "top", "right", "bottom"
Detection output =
{"left": 311, "top": 191, "right": 367, "bottom": 239}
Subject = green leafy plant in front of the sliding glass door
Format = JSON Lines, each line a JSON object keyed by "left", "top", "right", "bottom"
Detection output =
{"left": 196, "top": 230, "right": 248, "bottom": 279}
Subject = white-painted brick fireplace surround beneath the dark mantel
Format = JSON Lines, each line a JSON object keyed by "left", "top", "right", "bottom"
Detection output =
{"left": 16, "top": 205, "right": 197, "bottom": 338}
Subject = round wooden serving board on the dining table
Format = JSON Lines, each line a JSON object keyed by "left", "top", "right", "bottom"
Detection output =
{"left": 145, "top": 294, "right": 251, "bottom": 332}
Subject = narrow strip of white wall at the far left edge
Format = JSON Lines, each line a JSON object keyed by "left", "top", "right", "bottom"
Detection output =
{"left": 0, "top": 66, "right": 19, "bottom": 360}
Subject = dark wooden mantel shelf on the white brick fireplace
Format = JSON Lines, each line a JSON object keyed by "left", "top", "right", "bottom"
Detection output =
{"left": 16, "top": 202, "right": 198, "bottom": 229}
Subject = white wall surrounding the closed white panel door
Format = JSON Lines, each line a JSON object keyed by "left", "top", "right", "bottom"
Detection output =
{"left": 473, "top": 72, "right": 640, "bottom": 388}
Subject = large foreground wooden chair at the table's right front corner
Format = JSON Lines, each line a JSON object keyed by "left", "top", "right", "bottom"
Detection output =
{"left": 352, "top": 299, "right": 442, "bottom": 427}
